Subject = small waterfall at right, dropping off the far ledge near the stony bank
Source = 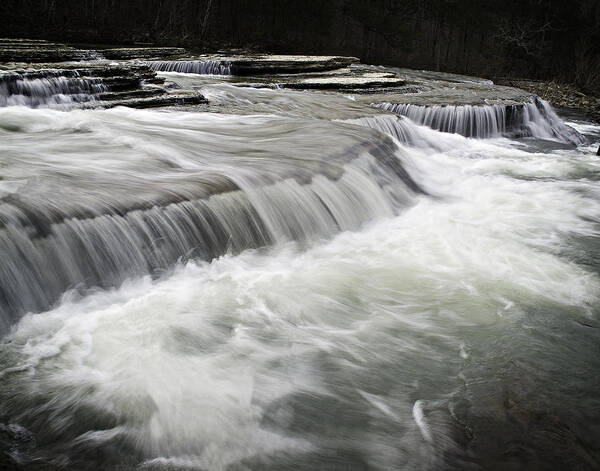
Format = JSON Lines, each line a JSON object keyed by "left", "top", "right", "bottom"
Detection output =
{"left": 375, "top": 98, "right": 586, "bottom": 145}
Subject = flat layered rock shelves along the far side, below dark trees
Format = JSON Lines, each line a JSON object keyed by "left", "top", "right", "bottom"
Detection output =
{"left": 0, "top": 39, "right": 600, "bottom": 119}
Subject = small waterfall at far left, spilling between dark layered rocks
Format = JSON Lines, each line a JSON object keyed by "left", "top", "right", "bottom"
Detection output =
{"left": 0, "top": 72, "right": 108, "bottom": 108}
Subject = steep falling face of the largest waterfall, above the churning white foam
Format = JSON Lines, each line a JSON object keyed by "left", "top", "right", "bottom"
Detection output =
{"left": 0, "top": 155, "right": 418, "bottom": 331}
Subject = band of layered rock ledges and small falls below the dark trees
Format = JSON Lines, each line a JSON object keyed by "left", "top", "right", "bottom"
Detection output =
{"left": 0, "top": 39, "right": 600, "bottom": 148}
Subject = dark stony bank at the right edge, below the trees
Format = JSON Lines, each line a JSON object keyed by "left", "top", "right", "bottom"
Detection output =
{"left": 494, "top": 79, "right": 600, "bottom": 123}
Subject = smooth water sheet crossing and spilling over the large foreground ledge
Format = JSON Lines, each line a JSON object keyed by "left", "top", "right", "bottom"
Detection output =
{"left": 0, "top": 108, "right": 420, "bottom": 332}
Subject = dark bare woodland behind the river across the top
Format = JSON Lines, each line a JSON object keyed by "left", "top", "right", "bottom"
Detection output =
{"left": 0, "top": 0, "right": 600, "bottom": 91}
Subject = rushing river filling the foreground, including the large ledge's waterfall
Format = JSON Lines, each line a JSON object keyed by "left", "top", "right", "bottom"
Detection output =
{"left": 0, "top": 75, "right": 600, "bottom": 471}
